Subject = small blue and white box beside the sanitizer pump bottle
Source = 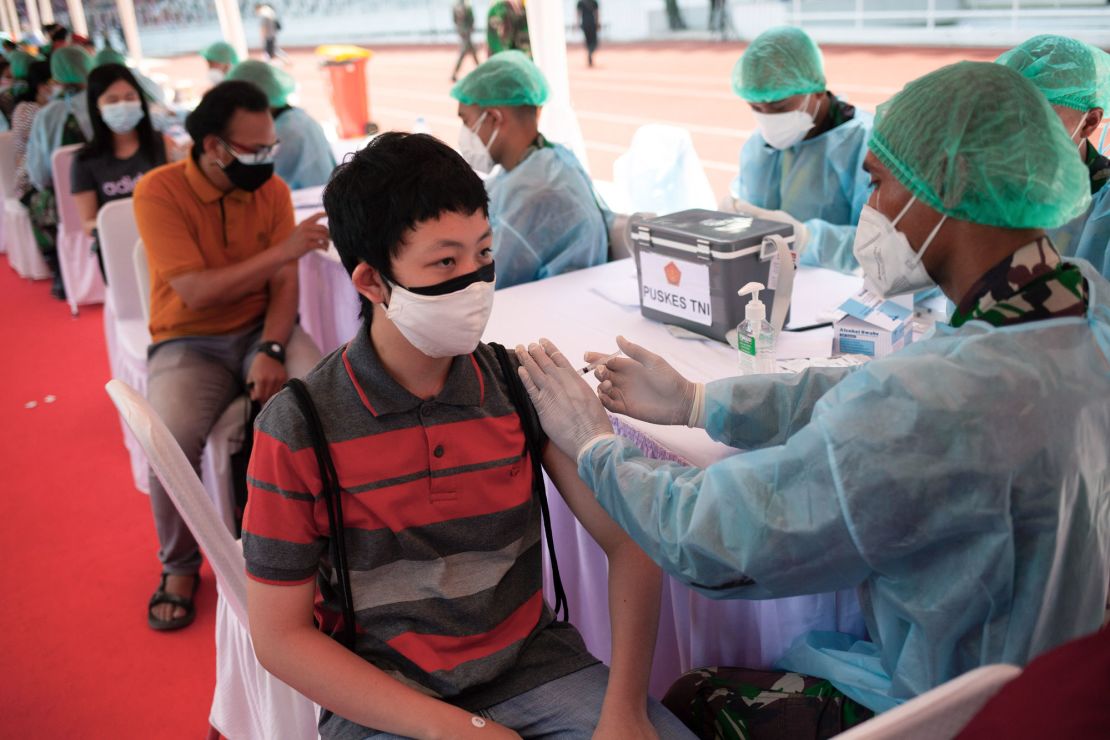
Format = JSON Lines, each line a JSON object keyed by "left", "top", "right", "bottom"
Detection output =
{"left": 833, "top": 290, "right": 914, "bottom": 357}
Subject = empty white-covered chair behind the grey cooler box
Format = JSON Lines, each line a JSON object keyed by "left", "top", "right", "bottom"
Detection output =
{"left": 613, "top": 123, "right": 717, "bottom": 213}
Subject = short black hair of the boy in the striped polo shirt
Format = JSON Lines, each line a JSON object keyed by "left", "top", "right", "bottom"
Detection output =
{"left": 324, "top": 131, "right": 490, "bottom": 321}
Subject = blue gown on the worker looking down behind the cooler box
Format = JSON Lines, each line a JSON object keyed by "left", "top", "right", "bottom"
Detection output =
{"left": 733, "top": 109, "right": 874, "bottom": 273}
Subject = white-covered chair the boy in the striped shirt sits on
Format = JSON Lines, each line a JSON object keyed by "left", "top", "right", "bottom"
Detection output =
{"left": 104, "top": 381, "right": 319, "bottom": 740}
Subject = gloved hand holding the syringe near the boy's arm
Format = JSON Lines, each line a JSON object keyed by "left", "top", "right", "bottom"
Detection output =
{"left": 586, "top": 336, "right": 700, "bottom": 426}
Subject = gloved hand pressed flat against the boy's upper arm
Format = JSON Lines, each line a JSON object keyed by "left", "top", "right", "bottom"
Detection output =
{"left": 516, "top": 339, "right": 613, "bottom": 459}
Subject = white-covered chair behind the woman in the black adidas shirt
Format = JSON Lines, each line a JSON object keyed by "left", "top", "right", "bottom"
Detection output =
{"left": 50, "top": 144, "right": 104, "bottom": 316}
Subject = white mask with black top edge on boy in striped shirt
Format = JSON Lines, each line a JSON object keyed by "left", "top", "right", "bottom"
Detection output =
{"left": 385, "top": 262, "right": 495, "bottom": 357}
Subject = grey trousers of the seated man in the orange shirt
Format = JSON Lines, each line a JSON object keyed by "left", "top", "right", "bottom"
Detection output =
{"left": 147, "top": 325, "right": 320, "bottom": 575}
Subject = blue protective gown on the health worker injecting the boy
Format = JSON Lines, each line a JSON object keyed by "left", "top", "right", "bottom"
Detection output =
{"left": 578, "top": 262, "right": 1110, "bottom": 711}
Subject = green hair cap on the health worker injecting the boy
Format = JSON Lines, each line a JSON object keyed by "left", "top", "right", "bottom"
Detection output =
{"left": 867, "top": 62, "right": 1091, "bottom": 229}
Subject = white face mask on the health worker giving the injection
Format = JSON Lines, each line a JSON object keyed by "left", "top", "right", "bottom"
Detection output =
{"left": 851, "top": 197, "right": 948, "bottom": 298}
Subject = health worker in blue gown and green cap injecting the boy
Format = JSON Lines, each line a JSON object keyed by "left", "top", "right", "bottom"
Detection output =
{"left": 517, "top": 62, "right": 1110, "bottom": 737}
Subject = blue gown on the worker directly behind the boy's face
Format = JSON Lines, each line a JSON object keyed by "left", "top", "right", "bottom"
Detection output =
{"left": 486, "top": 144, "right": 608, "bottom": 288}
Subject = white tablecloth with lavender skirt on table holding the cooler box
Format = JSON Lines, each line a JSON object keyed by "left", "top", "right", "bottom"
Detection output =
{"left": 485, "top": 260, "right": 864, "bottom": 697}
